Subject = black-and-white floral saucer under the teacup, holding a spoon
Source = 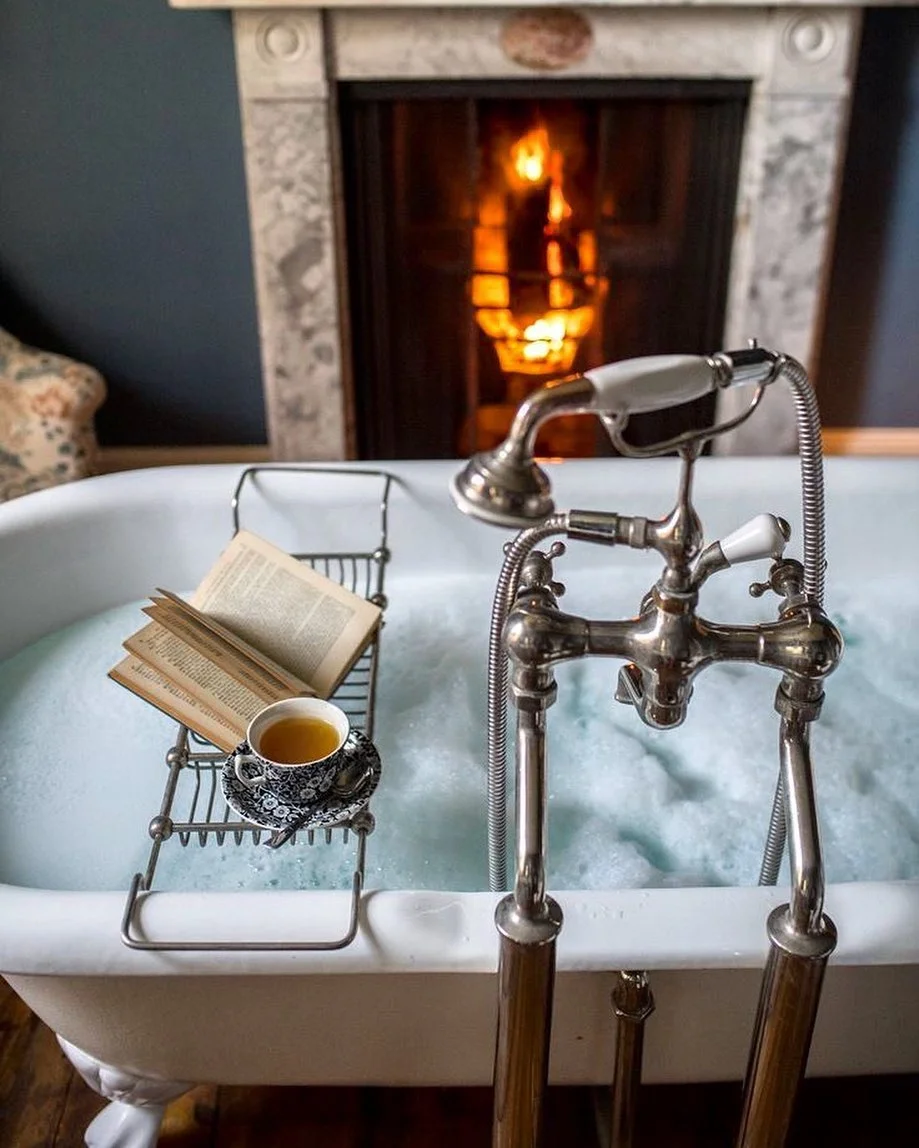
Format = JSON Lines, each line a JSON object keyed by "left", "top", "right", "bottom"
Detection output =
{"left": 220, "top": 729, "right": 382, "bottom": 829}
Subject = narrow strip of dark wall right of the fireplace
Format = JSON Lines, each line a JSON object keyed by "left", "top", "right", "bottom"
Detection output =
{"left": 817, "top": 8, "right": 919, "bottom": 426}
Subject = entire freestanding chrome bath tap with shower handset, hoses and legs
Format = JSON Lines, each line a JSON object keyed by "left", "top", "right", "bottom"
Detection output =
{"left": 453, "top": 344, "right": 842, "bottom": 1148}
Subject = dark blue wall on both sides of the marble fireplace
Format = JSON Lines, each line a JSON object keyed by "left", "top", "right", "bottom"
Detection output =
{"left": 0, "top": 0, "right": 919, "bottom": 445}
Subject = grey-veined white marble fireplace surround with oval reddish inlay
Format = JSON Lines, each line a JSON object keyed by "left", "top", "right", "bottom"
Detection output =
{"left": 172, "top": 0, "right": 860, "bottom": 459}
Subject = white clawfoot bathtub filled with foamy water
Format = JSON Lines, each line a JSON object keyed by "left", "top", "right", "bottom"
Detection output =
{"left": 0, "top": 459, "right": 919, "bottom": 1143}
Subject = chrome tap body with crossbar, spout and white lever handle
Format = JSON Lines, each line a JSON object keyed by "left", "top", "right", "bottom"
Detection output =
{"left": 504, "top": 452, "right": 842, "bottom": 729}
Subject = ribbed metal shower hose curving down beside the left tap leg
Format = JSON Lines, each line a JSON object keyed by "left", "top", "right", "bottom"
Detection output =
{"left": 488, "top": 514, "right": 568, "bottom": 893}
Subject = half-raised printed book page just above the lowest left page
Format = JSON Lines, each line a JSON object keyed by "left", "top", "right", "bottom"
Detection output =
{"left": 124, "top": 622, "right": 283, "bottom": 732}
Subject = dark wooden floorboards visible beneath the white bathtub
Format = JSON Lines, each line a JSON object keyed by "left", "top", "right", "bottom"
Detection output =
{"left": 0, "top": 979, "right": 919, "bottom": 1148}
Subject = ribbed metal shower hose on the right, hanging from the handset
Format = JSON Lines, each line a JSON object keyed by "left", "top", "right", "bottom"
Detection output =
{"left": 760, "top": 356, "right": 826, "bottom": 885}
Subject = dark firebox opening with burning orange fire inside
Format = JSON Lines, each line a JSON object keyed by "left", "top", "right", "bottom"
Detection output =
{"left": 338, "top": 80, "right": 749, "bottom": 458}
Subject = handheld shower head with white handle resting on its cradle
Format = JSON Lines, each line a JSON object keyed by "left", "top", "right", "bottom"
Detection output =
{"left": 451, "top": 347, "right": 777, "bottom": 527}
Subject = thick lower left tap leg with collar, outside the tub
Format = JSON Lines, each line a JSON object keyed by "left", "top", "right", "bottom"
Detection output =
{"left": 491, "top": 895, "right": 562, "bottom": 1148}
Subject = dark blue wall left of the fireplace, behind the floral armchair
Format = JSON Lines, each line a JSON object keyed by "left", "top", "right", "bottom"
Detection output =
{"left": 0, "top": 0, "right": 265, "bottom": 444}
